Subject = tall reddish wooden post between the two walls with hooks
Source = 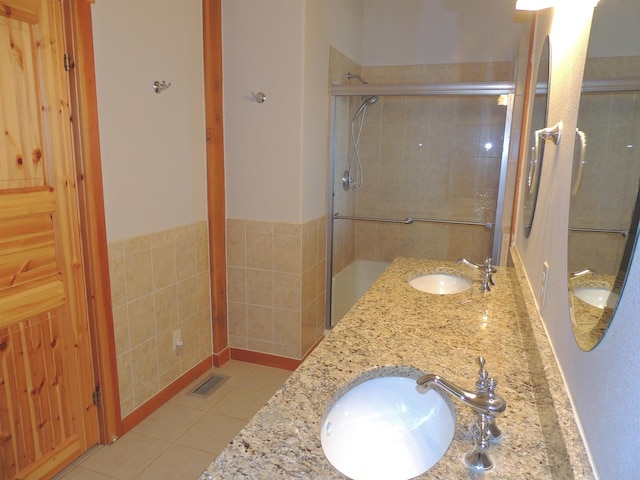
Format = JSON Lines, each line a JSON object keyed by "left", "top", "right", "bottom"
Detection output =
{"left": 202, "top": 0, "right": 228, "bottom": 359}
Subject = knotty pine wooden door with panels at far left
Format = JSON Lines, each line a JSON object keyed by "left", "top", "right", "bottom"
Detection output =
{"left": 0, "top": 0, "right": 98, "bottom": 480}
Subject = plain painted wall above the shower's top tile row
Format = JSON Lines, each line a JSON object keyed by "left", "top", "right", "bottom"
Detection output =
{"left": 361, "top": 0, "right": 529, "bottom": 66}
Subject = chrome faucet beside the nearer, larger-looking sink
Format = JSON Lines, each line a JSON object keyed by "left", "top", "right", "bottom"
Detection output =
{"left": 417, "top": 357, "right": 507, "bottom": 471}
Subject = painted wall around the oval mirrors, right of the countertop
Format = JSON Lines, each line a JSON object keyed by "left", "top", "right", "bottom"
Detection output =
{"left": 516, "top": 2, "right": 640, "bottom": 480}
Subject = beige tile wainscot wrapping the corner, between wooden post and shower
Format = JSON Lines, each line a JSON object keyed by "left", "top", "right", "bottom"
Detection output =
{"left": 227, "top": 217, "right": 327, "bottom": 359}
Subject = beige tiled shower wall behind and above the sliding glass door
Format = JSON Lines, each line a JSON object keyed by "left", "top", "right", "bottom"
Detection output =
{"left": 330, "top": 49, "right": 515, "bottom": 274}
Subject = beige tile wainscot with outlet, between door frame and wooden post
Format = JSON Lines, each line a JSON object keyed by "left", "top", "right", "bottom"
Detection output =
{"left": 109, "top": 222, "right": 213, "bottom": 417}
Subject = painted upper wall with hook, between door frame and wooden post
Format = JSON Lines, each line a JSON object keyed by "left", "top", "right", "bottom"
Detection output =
{"left": 92, "top": 0, "right": 207, "bottom": 241}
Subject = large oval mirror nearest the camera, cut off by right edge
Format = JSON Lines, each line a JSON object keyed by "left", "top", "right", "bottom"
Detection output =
{"left": 568, "top": 0, "right": 640, "bottom": 351}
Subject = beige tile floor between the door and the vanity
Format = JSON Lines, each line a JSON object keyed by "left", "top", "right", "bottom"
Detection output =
{"left": 54, "top": 360, "right": 291, "bottom": 480}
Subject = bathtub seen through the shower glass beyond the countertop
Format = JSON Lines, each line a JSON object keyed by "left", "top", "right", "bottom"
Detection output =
{"left": 331, "top": 260, "right": 389, "bottom": 326}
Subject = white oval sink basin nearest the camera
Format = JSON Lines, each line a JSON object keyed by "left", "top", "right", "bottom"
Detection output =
{"left": 320, "top": 376, "right": 456, "bottom": 480}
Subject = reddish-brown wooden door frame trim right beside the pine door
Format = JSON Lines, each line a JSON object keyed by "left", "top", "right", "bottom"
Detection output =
{"left": 63, "top": 0, "right": 122, "bottom": 443}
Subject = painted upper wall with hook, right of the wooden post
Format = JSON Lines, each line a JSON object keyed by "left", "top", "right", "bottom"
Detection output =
{"left": 222, "top": 0, "right": 304, "bottom": 223}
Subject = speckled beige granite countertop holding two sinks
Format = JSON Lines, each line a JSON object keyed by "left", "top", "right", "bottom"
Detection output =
{"left": 200, "top": 252, "right": 595, "bottom": 480}
